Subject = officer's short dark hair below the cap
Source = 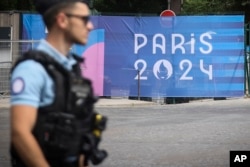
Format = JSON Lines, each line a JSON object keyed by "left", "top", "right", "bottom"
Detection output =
{"left": 42, "top": 2, "right": 76, "bottom": 30}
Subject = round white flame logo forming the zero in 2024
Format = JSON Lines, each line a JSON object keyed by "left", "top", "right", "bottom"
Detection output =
{"left": 153, "top": 60, "right": 173, "bottom": 80}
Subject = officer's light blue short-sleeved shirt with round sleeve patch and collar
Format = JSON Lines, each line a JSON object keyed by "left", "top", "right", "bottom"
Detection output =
{"left": 11, "top": 40, "right": 76, "bottom": 108}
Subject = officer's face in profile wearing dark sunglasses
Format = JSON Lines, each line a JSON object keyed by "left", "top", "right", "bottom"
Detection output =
{"left": 64, "top": 2, "right": 94, "bottom": 45}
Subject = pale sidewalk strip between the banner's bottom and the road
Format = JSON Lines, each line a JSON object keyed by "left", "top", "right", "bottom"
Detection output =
{"left": 0, "top": 98, "right": 157, "bottom": 108}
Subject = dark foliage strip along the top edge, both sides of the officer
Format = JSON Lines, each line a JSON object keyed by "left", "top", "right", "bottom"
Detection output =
{"left": 0, "top": 0, "right": 250, "bottom": 20}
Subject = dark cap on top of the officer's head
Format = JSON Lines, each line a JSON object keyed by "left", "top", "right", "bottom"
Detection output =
{"left": 35, "top": 0, "right": 89, "bottom": 15}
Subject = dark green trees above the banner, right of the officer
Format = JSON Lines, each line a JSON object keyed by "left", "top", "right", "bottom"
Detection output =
{"left": 93, "top": 0, "right": 250, "bottom": 18}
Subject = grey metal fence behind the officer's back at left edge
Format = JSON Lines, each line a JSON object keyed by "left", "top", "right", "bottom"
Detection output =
{"left": 0, "top": 40, "right": 38, "bottom": 98}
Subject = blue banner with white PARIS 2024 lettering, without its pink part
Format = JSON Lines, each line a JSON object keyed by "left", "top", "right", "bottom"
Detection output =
{"left": 21, "top": 15, "right": 244, "bottom": 97}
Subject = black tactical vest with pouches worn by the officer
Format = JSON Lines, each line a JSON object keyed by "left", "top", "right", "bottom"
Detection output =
{"left": 11, "top": 50, "right": 107, "bottom": 167}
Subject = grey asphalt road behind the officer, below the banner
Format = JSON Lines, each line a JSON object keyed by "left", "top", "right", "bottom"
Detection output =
{"left": 0, "top": 99, "right": 250, "bottom": 167}
